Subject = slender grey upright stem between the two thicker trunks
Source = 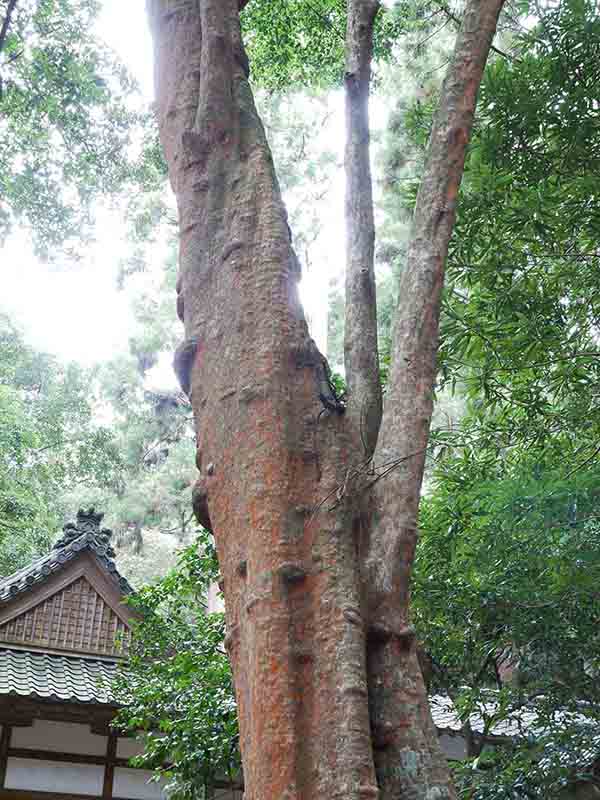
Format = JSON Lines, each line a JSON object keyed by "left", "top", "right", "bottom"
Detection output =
{"left": 344, "top": 0, "right": 381, "bottom": 456}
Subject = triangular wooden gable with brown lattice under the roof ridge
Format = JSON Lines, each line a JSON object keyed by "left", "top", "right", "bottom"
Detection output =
{"left": 0, "top": 572, "right": 130, "bottom": 656}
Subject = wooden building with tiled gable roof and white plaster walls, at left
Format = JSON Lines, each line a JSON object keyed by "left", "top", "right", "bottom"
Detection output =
{"left": 0, "top": 509, "right": 164, "bottom": 800}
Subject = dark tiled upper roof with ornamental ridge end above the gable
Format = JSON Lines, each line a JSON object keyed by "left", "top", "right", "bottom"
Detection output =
{"left": 0, "top": 508, "right": 133, "bottom": 604}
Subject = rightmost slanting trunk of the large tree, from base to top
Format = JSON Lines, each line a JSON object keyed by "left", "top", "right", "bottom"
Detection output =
{"left": 365, "top": 0, "right": 503, "bottom": 800}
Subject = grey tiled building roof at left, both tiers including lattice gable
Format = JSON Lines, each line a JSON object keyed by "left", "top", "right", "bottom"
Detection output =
{"left": 0, "top": 508, "right": 135, "bottom": 705}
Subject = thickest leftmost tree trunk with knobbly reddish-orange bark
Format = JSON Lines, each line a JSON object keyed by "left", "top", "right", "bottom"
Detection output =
{"left": 150, "top": 0, "right": 377, "bottom": 800}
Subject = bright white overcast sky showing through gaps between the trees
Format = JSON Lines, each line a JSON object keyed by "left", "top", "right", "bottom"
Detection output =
{"left": 0, "top": 0, "right": 396, "bottom": 374}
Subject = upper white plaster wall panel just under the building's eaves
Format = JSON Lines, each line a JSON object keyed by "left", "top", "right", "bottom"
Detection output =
{"left": 10, "top": 719, "right": 106, "bottom": 756}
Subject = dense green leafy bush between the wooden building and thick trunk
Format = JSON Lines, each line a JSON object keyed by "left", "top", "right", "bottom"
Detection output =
{"left": 115, "top": 533, "right": 240, "bottom": 798}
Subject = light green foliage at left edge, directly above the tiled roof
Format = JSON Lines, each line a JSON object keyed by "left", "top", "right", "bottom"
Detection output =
{"left": 0, "top": 315, "right": 120, "bottom": 575}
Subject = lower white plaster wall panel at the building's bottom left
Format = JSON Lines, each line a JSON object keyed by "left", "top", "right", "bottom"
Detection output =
{"left": 4, "top": 758, "right": 104, "bottom": 796}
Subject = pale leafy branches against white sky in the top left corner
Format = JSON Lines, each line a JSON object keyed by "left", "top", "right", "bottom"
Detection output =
{"left": 0, "top": 0, "right": 149, "bottom": 256}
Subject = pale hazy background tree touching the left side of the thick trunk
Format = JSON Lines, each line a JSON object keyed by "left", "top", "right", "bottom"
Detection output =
{"left": 65, "top": 255, "right": 197, "bottom": 585}
